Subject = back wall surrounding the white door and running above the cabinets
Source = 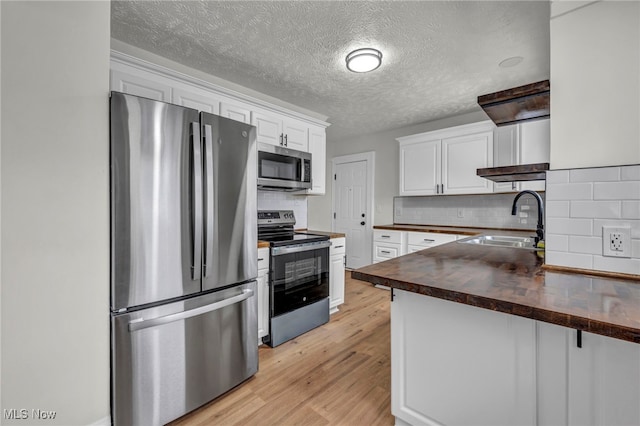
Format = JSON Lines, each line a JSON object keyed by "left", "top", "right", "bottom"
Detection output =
{"left": 307, "top": 107, "right": 487, "bottom": 231}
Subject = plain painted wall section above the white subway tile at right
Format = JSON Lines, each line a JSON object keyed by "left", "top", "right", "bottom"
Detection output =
{"left": 550, "top": 1, "right": 640, "bottom": 169}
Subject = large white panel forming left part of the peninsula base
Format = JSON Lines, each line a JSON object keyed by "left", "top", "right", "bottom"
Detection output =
{"left": 391, "top": 289, "right": 536, "bottom": 426}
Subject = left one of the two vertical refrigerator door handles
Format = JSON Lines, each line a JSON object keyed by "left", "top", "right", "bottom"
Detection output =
{"left": 191, "top": 122, "right": 202, "bottom": 280}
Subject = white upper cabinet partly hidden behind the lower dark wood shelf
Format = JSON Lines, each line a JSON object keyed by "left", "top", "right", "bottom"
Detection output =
{"left": 493, "top": 119, "right": 551, "bottom": 192}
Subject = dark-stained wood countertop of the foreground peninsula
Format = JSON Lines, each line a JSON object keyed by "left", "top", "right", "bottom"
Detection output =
{"left": 351, "top": 230, "right": 640, "bottom": 343}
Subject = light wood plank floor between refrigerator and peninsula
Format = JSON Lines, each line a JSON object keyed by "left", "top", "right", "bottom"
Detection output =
{"left": 172, "top": 272, "right": 394, "bottom": 426}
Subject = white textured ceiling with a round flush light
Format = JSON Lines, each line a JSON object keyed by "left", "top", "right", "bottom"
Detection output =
{"left": 111, "top": 0, "right": 549, "bottom": 140}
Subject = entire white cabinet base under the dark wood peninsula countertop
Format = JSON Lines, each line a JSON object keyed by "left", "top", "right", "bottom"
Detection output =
{"left": 391, "top": 289, "right": 640, "bottom": 426}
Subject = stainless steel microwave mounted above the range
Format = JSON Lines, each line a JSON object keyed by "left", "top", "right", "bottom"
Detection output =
{"left": 258, "top": 143, "right": 311, "bottom": 191}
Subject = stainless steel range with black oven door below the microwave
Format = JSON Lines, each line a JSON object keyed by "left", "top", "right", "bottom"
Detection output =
{"left": 258, "top": 210, "right": 331, "bottom": 347}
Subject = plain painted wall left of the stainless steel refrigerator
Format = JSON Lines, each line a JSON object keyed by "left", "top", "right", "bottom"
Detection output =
{"left": 0, "top": 1, "right": 110, "bottom": 425}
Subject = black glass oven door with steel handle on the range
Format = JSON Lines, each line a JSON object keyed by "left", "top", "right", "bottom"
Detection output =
{"left": 270, "top": 241, "right": 331, "bottom": 317}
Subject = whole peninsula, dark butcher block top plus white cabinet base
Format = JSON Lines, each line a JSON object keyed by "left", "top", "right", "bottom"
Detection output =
{"left": 351, "top": 228, "right": 640, "bottom": 426}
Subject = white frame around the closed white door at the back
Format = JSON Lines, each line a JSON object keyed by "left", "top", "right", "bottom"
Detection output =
{"left": 331, "top": 151, "right": 376, "bottom": 264}
